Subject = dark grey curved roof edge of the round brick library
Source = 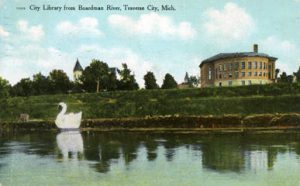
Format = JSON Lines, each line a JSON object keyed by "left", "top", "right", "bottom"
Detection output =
{"left": 200, "top": 52, "right": 277, "bottom": 67}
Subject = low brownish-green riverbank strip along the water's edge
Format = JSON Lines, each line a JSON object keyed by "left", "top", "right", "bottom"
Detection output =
{"left": 0, "top": 113, "right": 300, "bottom": 132}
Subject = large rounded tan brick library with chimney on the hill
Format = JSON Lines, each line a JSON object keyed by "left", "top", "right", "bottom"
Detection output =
{"left": 200, "top": 44, "right": 277, "bottom": 87}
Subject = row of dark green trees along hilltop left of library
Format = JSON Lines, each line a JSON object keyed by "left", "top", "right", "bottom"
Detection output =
{"left": 0, "top": 59, "right": 199, "bottom": 97}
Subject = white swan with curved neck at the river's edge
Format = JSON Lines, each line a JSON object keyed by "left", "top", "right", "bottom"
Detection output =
{"left": 55, "top": 102, "right": 82, "bottom": 129}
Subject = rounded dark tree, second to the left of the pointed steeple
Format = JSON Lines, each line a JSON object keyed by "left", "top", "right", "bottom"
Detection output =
{"left": 32, "top": 73, "right": 51, "bottom": 95}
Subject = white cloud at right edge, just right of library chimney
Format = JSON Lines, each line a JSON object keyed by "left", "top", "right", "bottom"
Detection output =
{"left": 260, "top": 36, "right": 300, "bottom": 74}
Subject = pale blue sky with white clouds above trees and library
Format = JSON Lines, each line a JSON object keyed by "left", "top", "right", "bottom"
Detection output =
{"left": 0, "top": 0, "right": 300, "bottom": 87}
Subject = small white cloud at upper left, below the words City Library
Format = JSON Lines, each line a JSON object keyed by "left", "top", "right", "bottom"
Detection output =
{"left": 17, "top": 20, "right": 45, "bottom": 41}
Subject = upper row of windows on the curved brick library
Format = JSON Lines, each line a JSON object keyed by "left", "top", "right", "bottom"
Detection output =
{"left": 219, "top": 61, "right": 271, "bottom": 71}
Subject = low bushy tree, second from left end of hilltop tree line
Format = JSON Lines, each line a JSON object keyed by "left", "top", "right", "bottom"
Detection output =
{"left": 11, "top": 78, "right": 34, "bottom": 96}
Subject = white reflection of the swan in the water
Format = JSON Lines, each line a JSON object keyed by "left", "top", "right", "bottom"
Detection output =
{"left": 56, "top": 130, "right": 83, "bottom": 160}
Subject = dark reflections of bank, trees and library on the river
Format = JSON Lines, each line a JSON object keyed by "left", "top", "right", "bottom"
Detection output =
{"left": 0, "top": 131, "right": 300, "bottom": 173}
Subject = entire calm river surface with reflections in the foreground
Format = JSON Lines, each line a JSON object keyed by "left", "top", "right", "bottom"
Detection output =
{"left": 0, "top": 132, "right": 300, "bottom": 186}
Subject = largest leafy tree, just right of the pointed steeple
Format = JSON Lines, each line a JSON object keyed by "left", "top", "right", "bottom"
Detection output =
{"left": 81, "top": 59, "right": 117, "bottom": 92}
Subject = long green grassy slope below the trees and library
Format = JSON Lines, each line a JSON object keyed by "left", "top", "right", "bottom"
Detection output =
{"left": 0, "top": 84, "right": 300, "bottom": 121}
